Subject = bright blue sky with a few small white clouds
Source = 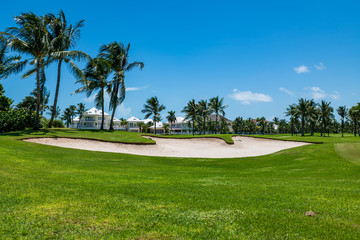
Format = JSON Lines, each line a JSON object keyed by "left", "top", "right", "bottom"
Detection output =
{"left": 0, "top": 1, "right": 360, "bottom": 119}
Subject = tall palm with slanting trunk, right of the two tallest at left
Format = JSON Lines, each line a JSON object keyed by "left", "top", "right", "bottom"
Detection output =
{"left": 46, "top": 11, "right": 89, "bottom": 128}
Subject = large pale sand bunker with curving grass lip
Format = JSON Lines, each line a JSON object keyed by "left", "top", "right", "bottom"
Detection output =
{"left": 24, "top": 136, "right": 309, "bottom": 158}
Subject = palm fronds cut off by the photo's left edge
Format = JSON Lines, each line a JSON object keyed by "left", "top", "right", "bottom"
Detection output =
{"left": 0, "top": 35, "right": 21, "bottom": 79}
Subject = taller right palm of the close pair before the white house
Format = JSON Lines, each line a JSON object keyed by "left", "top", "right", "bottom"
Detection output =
{"left": 99, "top": 42, "right": 144, "bottom": 130}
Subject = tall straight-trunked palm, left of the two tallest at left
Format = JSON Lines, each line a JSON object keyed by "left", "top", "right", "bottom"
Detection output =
{"left": 1, "top": 12, "right": 50, "bottom": 130}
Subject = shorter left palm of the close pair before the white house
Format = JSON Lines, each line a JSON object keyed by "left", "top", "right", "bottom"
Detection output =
{"left": 74, "top": 58, "right": 111, "bottom": 130}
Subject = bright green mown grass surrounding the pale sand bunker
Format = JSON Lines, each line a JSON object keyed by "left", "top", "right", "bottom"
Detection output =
{"left": 0, "top": 130, "right": 360, "bottom": 239}
